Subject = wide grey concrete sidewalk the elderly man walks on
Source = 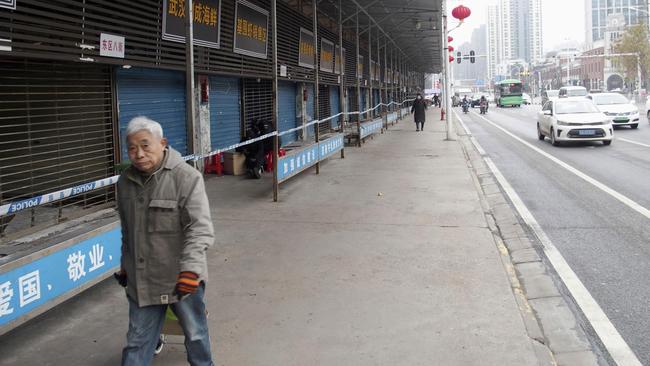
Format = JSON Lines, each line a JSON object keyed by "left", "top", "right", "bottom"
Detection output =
{"left": 0, "top": 109, "right": 539, "bottom": 366}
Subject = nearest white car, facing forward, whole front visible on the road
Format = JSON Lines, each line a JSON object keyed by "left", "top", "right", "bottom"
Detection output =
{"left": 537, "top": 98, "right": 614, "bottom": 146}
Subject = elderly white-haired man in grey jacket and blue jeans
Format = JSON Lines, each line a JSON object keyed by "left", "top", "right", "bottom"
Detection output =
{"left": 115, "top": 117, "right": 214, "bottom": 366}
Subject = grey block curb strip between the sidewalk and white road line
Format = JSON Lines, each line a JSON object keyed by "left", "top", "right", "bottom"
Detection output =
{"left": 454, "top": 118, "right": 609, "bottom": 366}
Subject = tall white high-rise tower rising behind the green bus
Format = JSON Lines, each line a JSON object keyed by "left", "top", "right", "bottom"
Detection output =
{"left": 487, "top": 0, "right": 543, "bottom": 83}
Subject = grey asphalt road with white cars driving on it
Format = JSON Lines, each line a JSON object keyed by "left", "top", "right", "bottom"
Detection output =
{"left": 457, "top": 101, "right": 650, "bottom": 365}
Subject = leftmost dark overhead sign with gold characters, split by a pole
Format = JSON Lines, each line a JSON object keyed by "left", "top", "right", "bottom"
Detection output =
{"left": 163, "top": 0, "right": 221, "bottom": 48}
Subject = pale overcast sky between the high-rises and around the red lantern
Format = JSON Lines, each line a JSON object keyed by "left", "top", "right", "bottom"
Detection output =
{"left": 447, "top": 0, "right": 585, "bottom": 52}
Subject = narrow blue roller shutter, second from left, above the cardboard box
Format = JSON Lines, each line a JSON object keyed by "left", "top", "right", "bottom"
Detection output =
{"left": 210, "top": 76, "right": 241, "bottom": 150}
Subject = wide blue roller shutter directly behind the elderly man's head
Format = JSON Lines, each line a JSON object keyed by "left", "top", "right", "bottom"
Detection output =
{"left": 117, "top": 67, "right": 187, "bottom": 160}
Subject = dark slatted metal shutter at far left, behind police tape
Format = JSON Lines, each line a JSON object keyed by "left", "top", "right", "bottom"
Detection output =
{"left": 0, "top": 57, "right": 115, "bottom": 236}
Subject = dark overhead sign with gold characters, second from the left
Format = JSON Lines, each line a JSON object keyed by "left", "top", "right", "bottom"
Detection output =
{"left": 233, "top": 0, "right": 269, "bottom": 59}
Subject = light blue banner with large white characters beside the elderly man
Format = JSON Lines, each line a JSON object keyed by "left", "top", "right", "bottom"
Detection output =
{"left": 0, "top": 227, "right": 121, "bottom": 332}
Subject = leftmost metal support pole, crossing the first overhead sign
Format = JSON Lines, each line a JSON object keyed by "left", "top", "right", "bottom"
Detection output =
{"left": 185, "top": 1, "right": 197, "bottom": 154}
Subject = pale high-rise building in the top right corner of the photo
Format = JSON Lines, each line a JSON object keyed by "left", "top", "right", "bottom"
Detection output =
{"left": 585, "top": 0, "right": 650, "bottom": 48}
